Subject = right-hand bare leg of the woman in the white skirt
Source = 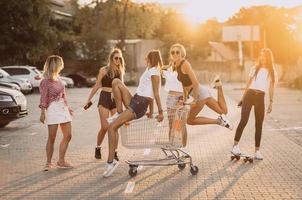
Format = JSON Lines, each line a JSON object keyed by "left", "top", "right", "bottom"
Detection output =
{"left": 59, "top": 122, "right": 71, "bottom": 164}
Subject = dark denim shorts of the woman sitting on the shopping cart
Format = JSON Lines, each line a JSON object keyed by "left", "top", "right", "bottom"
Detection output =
{"left": 128, "top": 94, "right": 149, "bottom": 119}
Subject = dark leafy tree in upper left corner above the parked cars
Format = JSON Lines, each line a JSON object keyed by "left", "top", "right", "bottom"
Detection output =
{"left": 0, "top": 0, "right": 57, "bottom": 64}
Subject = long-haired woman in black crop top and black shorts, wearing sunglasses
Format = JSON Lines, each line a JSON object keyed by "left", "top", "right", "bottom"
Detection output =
{"left": 86, "top": 48, "right": 124, "bottom": 160}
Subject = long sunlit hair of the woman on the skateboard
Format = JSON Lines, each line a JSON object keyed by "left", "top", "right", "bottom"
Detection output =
{"left": 255, "top": 48, "right": 276, "bottom": 83}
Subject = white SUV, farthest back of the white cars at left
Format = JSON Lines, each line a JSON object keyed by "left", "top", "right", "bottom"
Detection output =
{"left": 2, "top": 66, "right": 43, "bottom": 88}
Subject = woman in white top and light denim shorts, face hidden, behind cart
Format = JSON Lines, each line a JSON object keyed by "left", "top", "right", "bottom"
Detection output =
{"left": 161, "top": 62, "right": 187, "bottom": 145}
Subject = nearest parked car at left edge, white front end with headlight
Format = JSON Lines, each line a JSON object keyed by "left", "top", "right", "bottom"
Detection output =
{"left": 0, "top": 88, "right": 28, "bottom": 128}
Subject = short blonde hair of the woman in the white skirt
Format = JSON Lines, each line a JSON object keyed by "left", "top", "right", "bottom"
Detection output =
{"left": 43, "top": 55, "right": 64, "bottom": 80}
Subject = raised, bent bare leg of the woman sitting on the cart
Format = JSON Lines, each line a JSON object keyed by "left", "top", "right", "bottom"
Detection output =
{"left": 112, "top": 78, "right": 132, "bottom": 113}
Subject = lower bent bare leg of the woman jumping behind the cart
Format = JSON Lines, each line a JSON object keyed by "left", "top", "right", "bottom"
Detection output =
{"left": 187, "top": 99, "right": 219, "bottom": 125}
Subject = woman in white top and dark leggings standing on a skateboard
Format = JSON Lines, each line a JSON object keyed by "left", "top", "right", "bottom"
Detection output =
{"left": 231, "top": 48, "right": 277, "bottom": 160}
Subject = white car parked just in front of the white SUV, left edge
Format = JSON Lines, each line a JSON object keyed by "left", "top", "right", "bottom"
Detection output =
{"left": 0, "top": 69, "right": 33, "bottom": 94}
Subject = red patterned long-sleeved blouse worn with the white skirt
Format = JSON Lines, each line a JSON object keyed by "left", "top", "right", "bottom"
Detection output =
{"left": 39, "top": 79, "right": 68, "bottom": 109}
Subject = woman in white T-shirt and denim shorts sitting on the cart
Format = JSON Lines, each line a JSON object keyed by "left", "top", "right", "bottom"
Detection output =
{"left": 103, "top": 50, "right": 164, "bottom": 177}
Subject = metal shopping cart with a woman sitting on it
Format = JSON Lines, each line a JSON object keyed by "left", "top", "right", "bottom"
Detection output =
{"left": 120, "top": 106, "right": 198, "bottom": 177}
